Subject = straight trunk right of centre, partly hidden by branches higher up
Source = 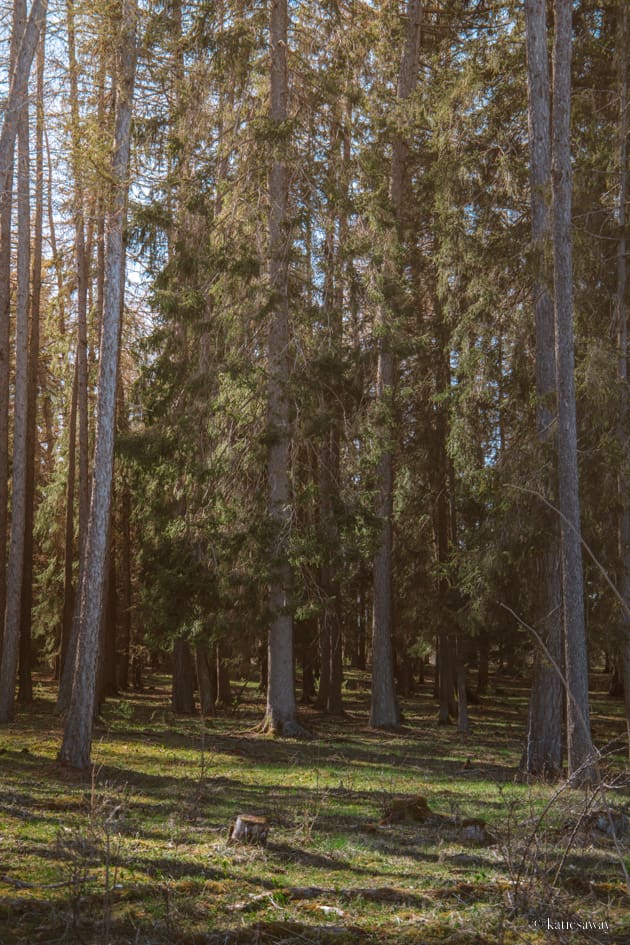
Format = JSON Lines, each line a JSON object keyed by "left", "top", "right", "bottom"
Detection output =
{"left": 370, "top": 0, "right": 422, "bottom": 728}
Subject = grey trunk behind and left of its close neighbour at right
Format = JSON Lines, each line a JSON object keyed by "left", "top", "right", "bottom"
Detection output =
{"left": 521, "top": 0, "right": 562, "bottom": 775}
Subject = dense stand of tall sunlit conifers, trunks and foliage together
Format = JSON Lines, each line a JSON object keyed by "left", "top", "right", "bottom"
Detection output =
{"left": 0, "top": 0, "right": 630, "bottom": 781}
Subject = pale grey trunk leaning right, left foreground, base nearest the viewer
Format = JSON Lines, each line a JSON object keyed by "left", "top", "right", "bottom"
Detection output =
{"left": 60, "top": 0, "right": 137, "bottom": 768}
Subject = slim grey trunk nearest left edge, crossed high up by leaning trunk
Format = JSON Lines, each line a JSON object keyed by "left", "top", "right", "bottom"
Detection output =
{"left": 0, "top": 0, "right": 31, "bottom": 722}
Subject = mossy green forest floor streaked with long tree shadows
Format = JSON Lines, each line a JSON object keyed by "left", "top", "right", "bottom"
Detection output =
{"left": 0, "top": 674, "right": 630, "bottom": 945}
